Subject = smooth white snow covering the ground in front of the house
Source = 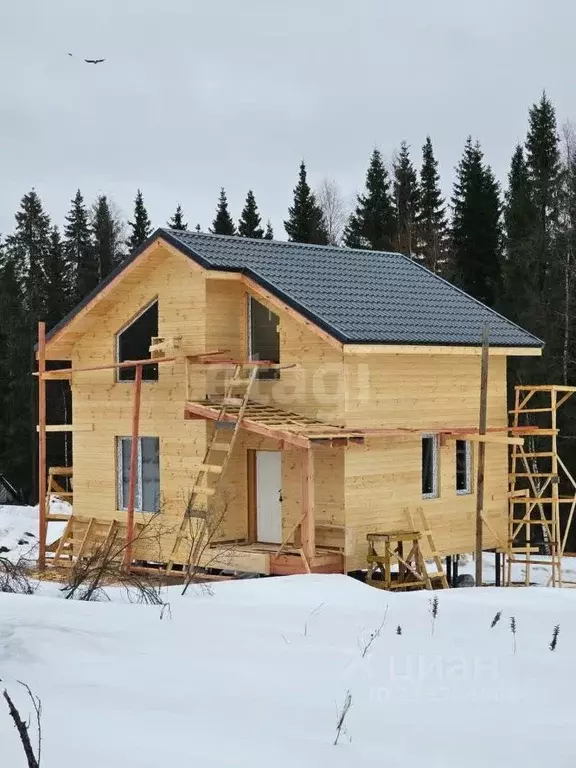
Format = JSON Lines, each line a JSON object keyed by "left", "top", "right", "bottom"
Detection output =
{"left": 0, "top": 510, "right": 576, "bottom": 768}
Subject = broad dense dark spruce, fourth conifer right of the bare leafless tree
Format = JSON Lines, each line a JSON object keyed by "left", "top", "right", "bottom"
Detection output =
{"left": 452, "top": 138, "right": 502, "bottom": 306}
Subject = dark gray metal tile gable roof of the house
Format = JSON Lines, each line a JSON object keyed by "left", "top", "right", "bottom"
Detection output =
{"left": 47, "top": 229, "right": 544, "bottom": 347}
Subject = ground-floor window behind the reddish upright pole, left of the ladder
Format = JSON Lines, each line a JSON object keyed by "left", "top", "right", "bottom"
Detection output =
{"left": 117, "top": 437, "right": 160, "bottom": 512}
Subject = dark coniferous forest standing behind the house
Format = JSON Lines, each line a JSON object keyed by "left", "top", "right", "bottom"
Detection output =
{"left": 0, "top": 95, "right": 576, "bottom": 500}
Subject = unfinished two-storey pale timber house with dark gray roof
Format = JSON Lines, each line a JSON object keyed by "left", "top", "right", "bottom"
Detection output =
{"left": 39, "top": 229, "right": 543, "bottom": 574}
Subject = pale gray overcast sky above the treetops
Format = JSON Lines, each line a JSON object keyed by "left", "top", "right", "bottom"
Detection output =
{"left": 0, "top": 0, "right": 576, "bottom": 238}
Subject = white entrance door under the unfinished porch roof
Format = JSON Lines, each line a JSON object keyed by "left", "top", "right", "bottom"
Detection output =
{"left": 256, "top": 451, "right": 282, "bottom": 544}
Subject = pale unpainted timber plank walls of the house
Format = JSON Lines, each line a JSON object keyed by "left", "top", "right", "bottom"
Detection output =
{"left": 46, "top": 239, "right": 539, "bottom": 572}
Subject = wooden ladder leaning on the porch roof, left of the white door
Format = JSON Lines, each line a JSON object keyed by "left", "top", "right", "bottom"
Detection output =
{"left": 166, "top": 363, "right": 259, "bottom": 573}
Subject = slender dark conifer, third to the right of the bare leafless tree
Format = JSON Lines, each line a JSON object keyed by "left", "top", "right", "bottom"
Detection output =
{"left": 417, "top": 136, "right": 448, "bottom": 272}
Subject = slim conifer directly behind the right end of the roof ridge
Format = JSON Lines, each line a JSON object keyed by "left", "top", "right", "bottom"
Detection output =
{"left": 394, "top": 141, "right": 420, "bottom": 256}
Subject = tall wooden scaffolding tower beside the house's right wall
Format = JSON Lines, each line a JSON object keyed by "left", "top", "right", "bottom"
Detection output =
{"left": 505, "top": 385, "right": 576, "bottom": 587}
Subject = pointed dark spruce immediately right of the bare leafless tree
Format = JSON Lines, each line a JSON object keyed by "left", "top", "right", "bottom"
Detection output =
{"left": 344, "top": 149, "right": 396, "bottom": 251}
